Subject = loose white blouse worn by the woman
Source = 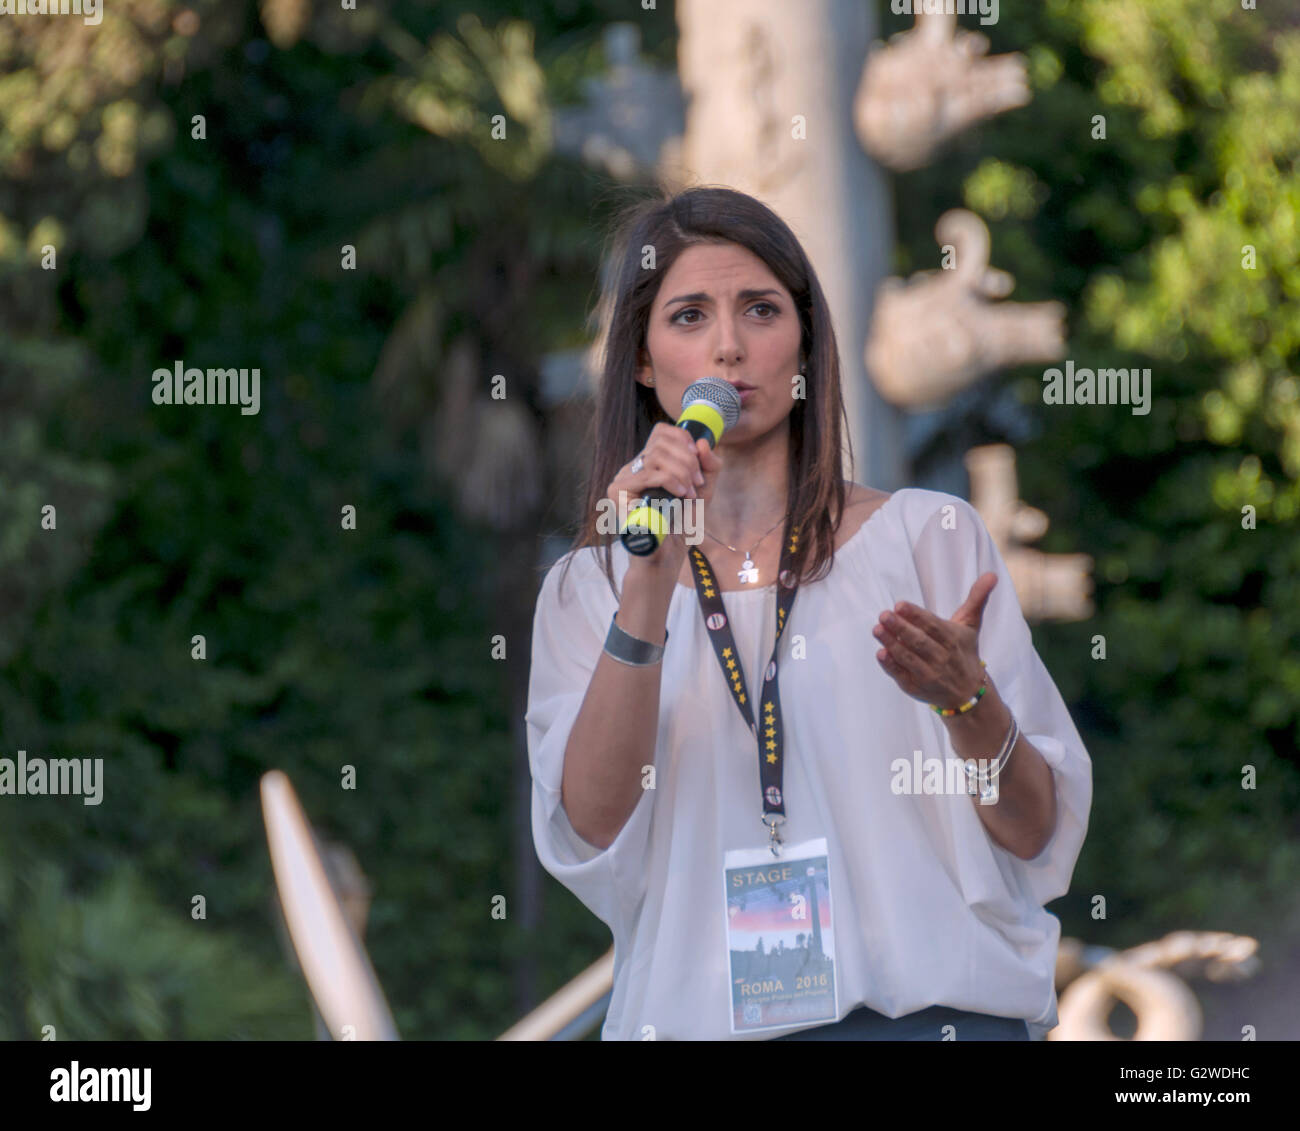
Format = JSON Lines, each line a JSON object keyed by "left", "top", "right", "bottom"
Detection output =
{"left": 525, "top": 488, "right": 1092, "bottom": 1040}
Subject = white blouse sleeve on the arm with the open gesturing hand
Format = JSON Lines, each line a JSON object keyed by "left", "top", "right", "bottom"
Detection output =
{"left": 911, "top": 491, "right": 1092, "bottom": 906}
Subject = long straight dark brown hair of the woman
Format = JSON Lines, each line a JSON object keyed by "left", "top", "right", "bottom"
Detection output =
{"left": 560, "top": 186, "right": 853, "bottom": 601}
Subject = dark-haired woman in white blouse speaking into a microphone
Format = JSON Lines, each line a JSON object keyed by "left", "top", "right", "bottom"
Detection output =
{"left": 527, "top": 189, "right": 1092, "bottom": 1040}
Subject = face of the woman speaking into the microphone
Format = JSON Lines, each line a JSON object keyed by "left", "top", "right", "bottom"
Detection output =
{"left": 637, "top": 243, "right": 802, "bottom": 443}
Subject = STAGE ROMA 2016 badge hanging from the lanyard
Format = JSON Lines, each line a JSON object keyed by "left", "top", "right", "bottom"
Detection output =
{"left": 723, "top": 837, "right": 840, "bottom": 1034}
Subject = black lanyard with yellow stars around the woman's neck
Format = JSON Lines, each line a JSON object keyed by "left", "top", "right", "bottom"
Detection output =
{"left": 690, "top": 527, "right": 800, "bottom": 855}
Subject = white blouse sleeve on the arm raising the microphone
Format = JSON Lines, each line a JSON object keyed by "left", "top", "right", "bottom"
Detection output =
{"left": 524, "top": 551, "right": 654, "bottom": 937}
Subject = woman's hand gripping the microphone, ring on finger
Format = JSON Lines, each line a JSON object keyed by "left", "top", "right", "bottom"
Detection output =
{"left": 606, "top": 421, "right": 723, "bottom": 584}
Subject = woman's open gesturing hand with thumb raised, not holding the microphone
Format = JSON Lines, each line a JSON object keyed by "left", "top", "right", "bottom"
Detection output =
{"left": 871, "top": 573, "right": 997, "bottom": 707}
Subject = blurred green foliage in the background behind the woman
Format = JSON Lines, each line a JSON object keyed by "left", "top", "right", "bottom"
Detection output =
{"left": 0, "top": 0, "right": 1300, "bottom": 1039}
